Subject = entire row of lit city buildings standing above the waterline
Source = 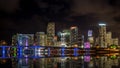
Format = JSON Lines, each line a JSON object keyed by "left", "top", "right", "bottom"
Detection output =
{"left": 12, "top": 22, "right": 119, "bottom": 48}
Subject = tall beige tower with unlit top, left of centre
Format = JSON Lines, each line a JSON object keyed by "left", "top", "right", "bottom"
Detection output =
{"left": 47, "top": 22, "right": 55, "bottom": 46}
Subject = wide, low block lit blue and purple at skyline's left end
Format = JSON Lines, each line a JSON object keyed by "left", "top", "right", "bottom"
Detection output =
{"left": 12, "top": 34, "right": 34, "bottom": 46}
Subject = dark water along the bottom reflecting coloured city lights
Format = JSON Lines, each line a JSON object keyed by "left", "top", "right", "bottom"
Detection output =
{"left": 0, "top": 54, "right": 120, "bottom": 68}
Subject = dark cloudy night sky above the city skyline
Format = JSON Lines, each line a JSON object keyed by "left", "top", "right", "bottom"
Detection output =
{"left": 0, "top": 0, "right": 120, "bottom": 42}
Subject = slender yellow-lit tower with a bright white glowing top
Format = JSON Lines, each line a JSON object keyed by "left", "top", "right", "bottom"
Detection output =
{"left": 99, "top": 24, "right": 107, "bottom": 48}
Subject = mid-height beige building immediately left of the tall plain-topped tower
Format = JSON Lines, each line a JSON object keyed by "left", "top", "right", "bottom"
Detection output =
{"left": 35, "top": 32, "right": 47, "bottom": 46}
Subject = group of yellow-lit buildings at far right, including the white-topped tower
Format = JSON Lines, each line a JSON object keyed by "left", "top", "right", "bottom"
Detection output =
{"left": 95, "top": 24, "right": 119, "bottom": 48}
